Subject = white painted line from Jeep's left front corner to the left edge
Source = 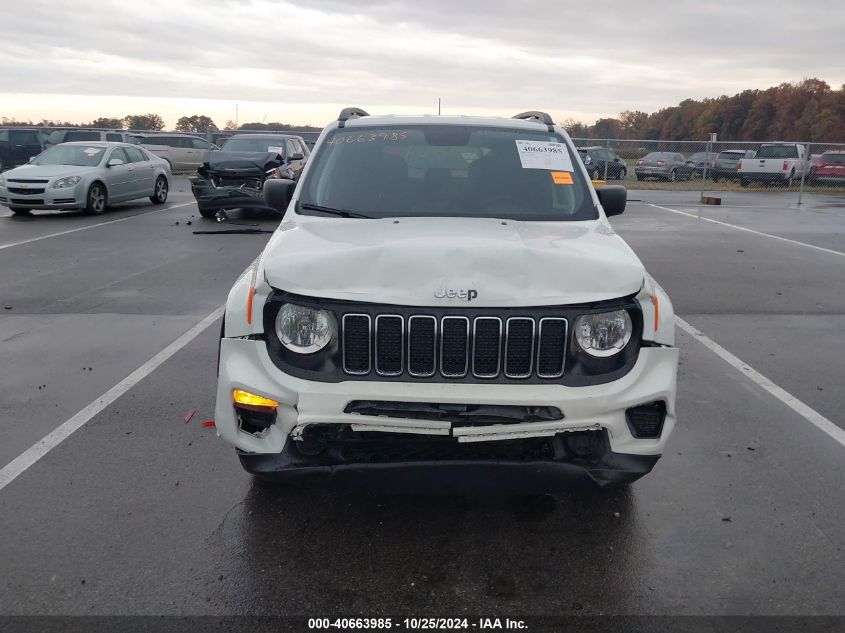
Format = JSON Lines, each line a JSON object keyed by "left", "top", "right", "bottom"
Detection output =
{"left": 0, "top": 306, "right": 225, "bottom": 490}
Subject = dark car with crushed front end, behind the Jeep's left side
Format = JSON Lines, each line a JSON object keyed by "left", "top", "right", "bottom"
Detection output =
{"left": 191, "top": 134, "right": 309, "bottom": 218}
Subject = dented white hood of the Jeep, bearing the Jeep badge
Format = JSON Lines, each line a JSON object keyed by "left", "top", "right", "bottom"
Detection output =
{"left": 262, "top": 216, "right": 645, "bottom": 307}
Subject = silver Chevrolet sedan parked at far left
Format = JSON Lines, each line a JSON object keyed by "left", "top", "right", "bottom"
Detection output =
{"left": 0, "top": 141, "right": 171, "bottom": 215}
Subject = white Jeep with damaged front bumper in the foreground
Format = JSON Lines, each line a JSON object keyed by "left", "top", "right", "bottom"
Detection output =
{"left": 215, "top": 108, "right": 678, "bottom": 494}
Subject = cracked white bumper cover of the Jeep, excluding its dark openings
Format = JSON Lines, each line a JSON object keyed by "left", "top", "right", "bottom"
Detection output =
{"left": 215, "top": 338, "right": 678, "bottom": 480}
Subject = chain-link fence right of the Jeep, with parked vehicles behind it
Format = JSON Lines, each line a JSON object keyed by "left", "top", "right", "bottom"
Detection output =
{"left": 573, "top": 138, "right": 845, "bottom": 198}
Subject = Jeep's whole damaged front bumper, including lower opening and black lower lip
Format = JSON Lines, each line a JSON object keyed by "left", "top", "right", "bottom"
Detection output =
{"left": 215, "top": 338, "right": 678, "bottom": 489}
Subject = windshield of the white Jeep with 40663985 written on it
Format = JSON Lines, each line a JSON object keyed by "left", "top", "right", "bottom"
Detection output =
{"left": 299, "top": 125, "right": 598, "bottom": 221}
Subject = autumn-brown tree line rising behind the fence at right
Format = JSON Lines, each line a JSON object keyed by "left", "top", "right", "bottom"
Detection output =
{"left": 561, "top": 79, "right": 845, "bottom": 143}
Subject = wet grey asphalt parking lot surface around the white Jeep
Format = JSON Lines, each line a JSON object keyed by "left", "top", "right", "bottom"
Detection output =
{"left": 0, "top": 179, "right": 845, "bottom": 616}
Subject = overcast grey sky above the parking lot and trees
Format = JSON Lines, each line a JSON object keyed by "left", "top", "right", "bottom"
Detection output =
{"left": 0, "top": 0, "right": 845, "bottom": 127}
